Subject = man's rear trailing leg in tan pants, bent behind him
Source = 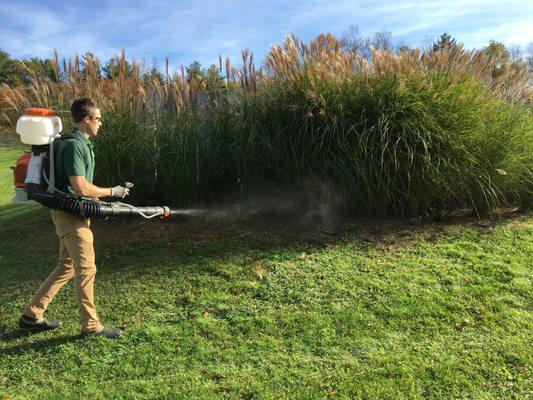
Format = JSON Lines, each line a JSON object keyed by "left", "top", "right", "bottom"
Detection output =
{"left": 24, "top": 238, "right": 74, "bottom": 320}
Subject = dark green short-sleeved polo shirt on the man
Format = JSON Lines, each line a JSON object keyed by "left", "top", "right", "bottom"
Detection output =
{"left": 54, "top": 129, "right": 94, "bottom": 195}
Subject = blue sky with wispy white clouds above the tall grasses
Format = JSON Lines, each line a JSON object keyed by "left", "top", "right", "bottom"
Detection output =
{"left": 0, "top": 0, "right": 533, "bottom": 70}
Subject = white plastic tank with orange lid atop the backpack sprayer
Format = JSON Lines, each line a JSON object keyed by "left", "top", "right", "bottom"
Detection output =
{"left": 17, "top": 108, "right": 63, "bottom": 145}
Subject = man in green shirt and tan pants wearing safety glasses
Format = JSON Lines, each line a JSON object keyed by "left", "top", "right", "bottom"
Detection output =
{"left": 19, "top": 98, "right": 129, "bottom": 338}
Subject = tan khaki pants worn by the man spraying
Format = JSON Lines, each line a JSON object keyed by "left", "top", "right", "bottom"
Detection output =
{"left": 24, "top": 210, "right": 102, "bottom": 332}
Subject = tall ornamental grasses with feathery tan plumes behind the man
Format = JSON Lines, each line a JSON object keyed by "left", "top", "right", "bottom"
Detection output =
{"left": 0, "top": 35, "right": 533, "bottom": 216}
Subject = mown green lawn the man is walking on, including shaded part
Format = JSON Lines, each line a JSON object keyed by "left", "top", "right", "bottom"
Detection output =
{"left": 0, "top": 148, "right": 533, "bottom": 399}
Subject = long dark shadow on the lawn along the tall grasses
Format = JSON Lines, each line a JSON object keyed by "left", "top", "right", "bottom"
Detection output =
{"left": 0, "top": 205, "right": 528, "bottom": 291}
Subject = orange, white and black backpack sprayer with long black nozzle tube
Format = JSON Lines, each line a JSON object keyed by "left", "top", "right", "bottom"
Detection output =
{"left": 12, "top": 108, "right": 177, "bottom": 218}
